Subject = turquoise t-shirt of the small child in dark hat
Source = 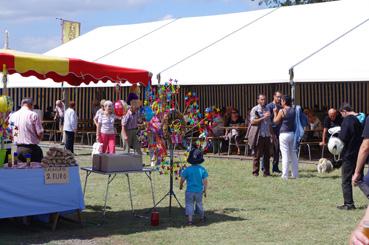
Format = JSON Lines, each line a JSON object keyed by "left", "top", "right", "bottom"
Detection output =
{"left": 181, "top": 164, "right": 208, "bottom": 192}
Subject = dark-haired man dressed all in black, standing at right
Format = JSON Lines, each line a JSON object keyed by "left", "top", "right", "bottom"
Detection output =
{"left": 337, "top": 103, "right": 363, "bottom": 210}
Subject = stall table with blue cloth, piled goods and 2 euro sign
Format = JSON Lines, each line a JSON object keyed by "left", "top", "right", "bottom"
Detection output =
{"left": 0, "top": 148, "right": 84, "bottom": 229}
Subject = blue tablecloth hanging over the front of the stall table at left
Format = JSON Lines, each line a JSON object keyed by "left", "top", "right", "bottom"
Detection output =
{"left": 0, "top": 166, "right": 84, "bottom": 218}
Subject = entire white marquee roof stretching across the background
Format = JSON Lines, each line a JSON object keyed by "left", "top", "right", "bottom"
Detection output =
{"left": 3, "top": 0, "right": 369, "bottom": 86}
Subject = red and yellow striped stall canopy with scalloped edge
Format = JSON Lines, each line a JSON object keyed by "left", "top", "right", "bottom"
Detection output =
{"left": 0, "top": 49, "right": 151, "bottom": 86}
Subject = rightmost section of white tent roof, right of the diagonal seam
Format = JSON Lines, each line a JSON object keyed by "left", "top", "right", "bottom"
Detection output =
{"left": 294, "top": 15, "right": 369, "bottom": 82}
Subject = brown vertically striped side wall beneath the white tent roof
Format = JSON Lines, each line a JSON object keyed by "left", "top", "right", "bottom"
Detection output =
{"left": 2, "top": 82, "right": 369, "bottom": 120}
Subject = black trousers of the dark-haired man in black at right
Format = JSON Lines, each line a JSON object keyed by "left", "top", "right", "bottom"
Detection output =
{"left": 341, "top": 159, "right": 356, "bottom": 205}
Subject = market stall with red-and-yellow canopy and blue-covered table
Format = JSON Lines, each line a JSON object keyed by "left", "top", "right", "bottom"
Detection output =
{"left": 0, "top": 49, "right": 152, "bottom": 228}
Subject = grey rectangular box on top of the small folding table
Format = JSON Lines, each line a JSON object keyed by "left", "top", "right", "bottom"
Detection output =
{"left": 100, "top": 153, "right": 143, "bottom": 172}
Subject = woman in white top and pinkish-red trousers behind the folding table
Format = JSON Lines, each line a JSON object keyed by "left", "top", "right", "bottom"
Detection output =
{"left": 96, "top": 100, "right": 116, "bottom": 154}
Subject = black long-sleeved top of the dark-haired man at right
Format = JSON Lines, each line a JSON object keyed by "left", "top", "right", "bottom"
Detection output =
{"left": 338, "top": 115, "right": 363, "bottom": 163}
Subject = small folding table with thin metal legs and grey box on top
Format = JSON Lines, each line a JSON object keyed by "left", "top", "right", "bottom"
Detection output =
{"left": 81, "top": 154, "right": 157, "bottom": 218}
